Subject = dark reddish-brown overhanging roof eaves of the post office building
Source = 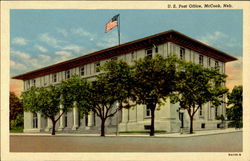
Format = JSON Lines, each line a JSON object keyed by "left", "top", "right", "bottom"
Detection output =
{"left": 12, "top": 30, "right": 237, "bottom": 80}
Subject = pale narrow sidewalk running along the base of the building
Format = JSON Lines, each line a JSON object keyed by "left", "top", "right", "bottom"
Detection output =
{"left": 10, "top": 128, "right": 242, "bottom": 138}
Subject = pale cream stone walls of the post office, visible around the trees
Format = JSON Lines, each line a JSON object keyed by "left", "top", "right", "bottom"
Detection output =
{"left": 14, "top": 30, "right": 235, "bottom": 133}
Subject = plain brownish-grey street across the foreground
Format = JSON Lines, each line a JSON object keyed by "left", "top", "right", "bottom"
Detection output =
{"left": 10, "top": 132, "right": 242, "bottom": 152}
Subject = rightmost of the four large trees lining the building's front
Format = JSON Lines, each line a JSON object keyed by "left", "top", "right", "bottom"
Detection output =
{"left": 171, "top": 60, "right": 227, "bottom": 134}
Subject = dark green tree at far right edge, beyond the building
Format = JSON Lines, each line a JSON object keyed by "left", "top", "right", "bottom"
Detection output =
{"left": 227, "top": 85, "right": 243, "bottom": 128}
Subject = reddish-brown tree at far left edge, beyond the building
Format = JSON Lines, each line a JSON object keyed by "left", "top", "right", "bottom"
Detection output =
{"left": 9, "top": 92, "right": 23, "bottom": 129}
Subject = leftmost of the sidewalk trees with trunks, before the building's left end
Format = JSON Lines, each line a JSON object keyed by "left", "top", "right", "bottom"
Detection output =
{"left": 21, "top": 85, "right": 63, "bottom": 135}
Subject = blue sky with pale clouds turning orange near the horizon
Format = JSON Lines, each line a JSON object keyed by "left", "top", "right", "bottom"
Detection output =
{"left": 10, "top": 9, "right": 243, "bottom": 95}
